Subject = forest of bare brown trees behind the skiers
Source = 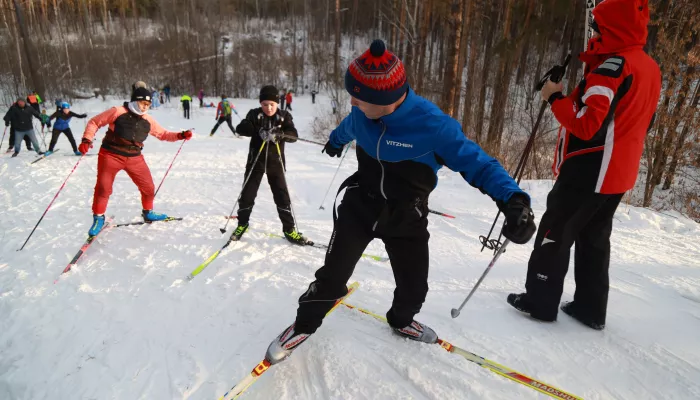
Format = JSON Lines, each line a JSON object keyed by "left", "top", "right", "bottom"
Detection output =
{"left": 0, "top": 0, "right": 700, "bottom": 220}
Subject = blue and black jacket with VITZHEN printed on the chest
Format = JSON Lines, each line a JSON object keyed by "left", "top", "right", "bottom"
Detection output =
{"left": 329, "top": 89, "right": 527, "bottom": 202}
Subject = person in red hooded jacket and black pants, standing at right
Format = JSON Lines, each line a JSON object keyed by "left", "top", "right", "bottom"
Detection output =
{"left": 508, "top": 0, "right": 661, "bottom": 330}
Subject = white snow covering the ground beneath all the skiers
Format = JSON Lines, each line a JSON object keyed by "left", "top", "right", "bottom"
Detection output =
{"left": 0, "top": 96, "right": 700, "bottom": 399}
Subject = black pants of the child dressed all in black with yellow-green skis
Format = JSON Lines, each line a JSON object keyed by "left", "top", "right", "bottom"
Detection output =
{"left": 238, "top": 148, "right": 294, "bottom": 232}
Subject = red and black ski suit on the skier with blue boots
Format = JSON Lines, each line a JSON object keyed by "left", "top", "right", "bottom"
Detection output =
{"left": 83, "top": 105, "right": 182, "bottom": 215}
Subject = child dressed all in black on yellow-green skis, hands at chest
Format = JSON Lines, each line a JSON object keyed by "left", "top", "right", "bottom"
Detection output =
{"left": 234, "top": 86, "right": 309, "bottom": 245}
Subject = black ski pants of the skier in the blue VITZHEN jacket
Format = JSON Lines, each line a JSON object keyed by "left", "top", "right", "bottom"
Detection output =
{"left": 294, "top": 181, "right": 430, "bottom": 334}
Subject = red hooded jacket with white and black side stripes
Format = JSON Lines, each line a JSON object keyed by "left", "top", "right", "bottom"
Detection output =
{"left": 549, "top": 0, "right": 661, "bottom": 194}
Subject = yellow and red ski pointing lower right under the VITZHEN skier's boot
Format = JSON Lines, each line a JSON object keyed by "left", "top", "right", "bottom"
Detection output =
{"left": 341, "top": 300, "right": 583, "bottom": 400}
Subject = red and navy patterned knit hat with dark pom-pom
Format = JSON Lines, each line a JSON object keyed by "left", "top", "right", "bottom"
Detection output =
{"left": 345, "top": 39, "right": 408, "bottom": 106}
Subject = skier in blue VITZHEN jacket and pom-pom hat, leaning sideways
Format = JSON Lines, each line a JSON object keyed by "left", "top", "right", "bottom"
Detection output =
{"left": 266, "top": 40, "right": 536, "bottom": 364}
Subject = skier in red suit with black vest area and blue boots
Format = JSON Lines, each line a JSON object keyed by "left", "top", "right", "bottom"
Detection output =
{"left": 78, "top": 87, "right": 192, "bottom": 236}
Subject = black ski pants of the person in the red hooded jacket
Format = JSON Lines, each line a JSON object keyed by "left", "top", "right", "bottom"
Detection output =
{"left": 525, "top": 181, "right": 624, "bottom": 324}
